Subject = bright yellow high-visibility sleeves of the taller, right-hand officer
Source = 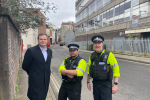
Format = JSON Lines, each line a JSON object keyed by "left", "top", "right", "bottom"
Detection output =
{"left": 87, "top": 50, "right": 120, "bottom": 77}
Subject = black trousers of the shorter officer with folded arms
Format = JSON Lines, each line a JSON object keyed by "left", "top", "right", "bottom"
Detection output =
{"left": 58, "top": 80, "right": 82, "bottom": 100}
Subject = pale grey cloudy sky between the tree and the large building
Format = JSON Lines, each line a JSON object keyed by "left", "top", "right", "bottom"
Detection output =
{"left": 43, "top": 0, "right": 76, "bottom": 28}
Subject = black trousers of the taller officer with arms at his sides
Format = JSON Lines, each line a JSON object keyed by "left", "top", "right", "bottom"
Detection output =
{"left": 93, "top": 80, "right": 112, "bottom": 100}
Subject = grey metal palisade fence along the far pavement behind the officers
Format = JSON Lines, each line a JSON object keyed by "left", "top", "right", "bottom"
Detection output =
{"left": 66, "top": 39, "right": 150, "bottom": 55}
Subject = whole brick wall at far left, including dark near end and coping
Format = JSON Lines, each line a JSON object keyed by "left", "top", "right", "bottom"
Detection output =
{"left": 0, "top": 8, "right": 20, "bottom": 100}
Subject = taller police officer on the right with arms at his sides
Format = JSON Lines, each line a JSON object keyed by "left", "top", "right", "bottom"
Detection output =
{"left": 87, "top": 35, "right": 120, "bottom": 100}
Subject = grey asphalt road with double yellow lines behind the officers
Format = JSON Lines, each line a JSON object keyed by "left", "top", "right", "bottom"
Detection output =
{"left": 50, "top": 45, "right": 150, "bottom": 100}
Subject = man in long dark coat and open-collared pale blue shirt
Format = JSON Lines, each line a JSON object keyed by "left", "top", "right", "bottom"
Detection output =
{"left": 22, "top": 33, "right": 52, "bottom": 100}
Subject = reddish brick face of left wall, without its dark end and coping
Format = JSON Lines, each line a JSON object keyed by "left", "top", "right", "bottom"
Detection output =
{"left": 7, "top": 17, "right": 20, "bottom": 100}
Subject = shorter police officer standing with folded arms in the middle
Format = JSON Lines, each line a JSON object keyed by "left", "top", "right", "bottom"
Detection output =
{"left": 58, "top": 44, "right": 87, "bottom": 100}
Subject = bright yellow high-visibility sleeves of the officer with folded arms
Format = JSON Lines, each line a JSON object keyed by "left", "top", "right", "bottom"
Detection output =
{"left": 59, "top": 57, "right": 87, "bottom": 77}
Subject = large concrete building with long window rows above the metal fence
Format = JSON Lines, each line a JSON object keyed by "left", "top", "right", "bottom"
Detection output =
{"left": 75, "top": 0, "right": 150, "bottom": 41}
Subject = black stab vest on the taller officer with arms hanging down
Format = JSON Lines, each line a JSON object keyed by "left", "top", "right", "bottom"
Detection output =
{"left": 90, "top": 51, "right": 113, "bottom": 80}
